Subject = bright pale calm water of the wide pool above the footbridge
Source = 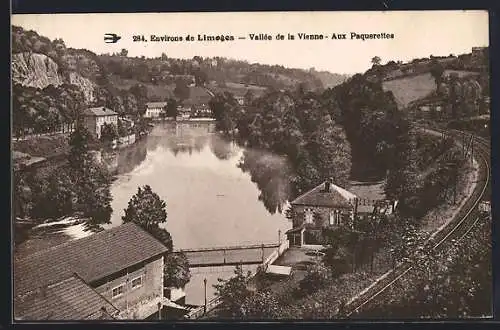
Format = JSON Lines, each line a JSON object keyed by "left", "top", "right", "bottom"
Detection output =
{"left": 106, "top": 123, "right": 291, "bottom": 249}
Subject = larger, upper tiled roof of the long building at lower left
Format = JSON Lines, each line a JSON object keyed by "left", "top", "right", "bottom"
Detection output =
{"left": 14, "top": 223, "right": 167, "bottom": 295}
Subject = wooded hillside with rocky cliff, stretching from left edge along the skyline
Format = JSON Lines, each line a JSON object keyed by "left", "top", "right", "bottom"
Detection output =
{"left": 12, "top": 26, "right": 348, "bottom": 137}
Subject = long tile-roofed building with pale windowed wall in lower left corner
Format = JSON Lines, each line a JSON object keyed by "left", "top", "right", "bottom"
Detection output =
{"left": 14, "top": 223, "right": 168, "bottom": 320}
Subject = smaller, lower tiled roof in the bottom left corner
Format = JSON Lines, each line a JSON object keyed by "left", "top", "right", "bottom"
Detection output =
{"left": 14, "top": 276, "right": 119, "bottom": 321}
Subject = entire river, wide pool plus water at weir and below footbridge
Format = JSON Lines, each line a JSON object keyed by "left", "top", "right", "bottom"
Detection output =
{"left": 16, "top": 122, "right": 292, "bottom": 305}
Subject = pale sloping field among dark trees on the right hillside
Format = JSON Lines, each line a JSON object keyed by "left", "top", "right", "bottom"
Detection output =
{"left": 383, "top": 73, "right": 436, "bottom": 109}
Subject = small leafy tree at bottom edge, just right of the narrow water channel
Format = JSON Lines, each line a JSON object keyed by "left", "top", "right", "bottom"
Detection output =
{"left": 214, "top": 265, "right": 252, "bottom": 318}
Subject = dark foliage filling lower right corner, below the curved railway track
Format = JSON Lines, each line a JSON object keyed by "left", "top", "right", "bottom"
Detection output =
{"left": 356, "top": 213, "right": 493, "bottom": 318}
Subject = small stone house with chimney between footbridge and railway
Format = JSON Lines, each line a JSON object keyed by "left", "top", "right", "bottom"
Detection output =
{"left": 286, "top": 179, "right": 397, "bottom": 246}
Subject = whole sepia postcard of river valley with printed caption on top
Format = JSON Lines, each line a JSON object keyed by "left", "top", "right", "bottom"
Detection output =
{"left": 11, "top": 11, "right": 493, "bottom": 322}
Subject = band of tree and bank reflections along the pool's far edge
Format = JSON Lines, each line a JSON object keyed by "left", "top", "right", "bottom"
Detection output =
{"left": 101, "top": 123, "right": 292, "bottom": 218}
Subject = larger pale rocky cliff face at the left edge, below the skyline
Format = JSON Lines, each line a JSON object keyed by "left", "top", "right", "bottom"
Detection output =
{"left": 12, "top": 53, "right": 63, "bottom": 88}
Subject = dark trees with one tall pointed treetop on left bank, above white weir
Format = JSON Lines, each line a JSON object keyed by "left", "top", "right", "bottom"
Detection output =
{"left": 13, "top": 126, "right": 112, "bottom": 230}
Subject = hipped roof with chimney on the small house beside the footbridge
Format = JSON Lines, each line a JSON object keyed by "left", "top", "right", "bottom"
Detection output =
{"left": 290, "top": 181, "right": 357, "bottom": 207}
